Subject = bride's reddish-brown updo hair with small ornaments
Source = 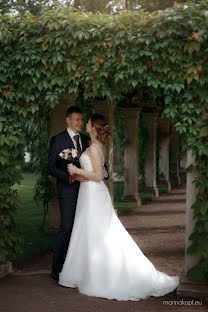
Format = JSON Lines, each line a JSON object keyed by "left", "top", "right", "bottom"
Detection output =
{"left": 90, "top": 114, "right": 111, "bottom": 145}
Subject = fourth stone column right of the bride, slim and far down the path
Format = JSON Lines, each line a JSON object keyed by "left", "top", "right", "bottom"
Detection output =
{"left": 170, "top": 131, "right": 181, "bottom": 184}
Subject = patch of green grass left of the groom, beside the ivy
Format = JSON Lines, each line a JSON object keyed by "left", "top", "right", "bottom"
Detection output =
{"left": 14, "top": 173, "right": 55, "bottom": 265}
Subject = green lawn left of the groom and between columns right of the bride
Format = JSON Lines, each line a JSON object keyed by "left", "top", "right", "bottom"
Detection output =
{"left": 15, "top": 173, "right": 169, "bottom": 265}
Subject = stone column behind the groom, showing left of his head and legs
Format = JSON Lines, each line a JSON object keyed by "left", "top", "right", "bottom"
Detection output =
{"left": 50, "top": 96, "right": 76, "bottom": 229}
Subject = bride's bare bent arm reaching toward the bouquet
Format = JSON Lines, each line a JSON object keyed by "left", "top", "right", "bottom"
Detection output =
{"left": 68, "top": 145, "right": 103, "bottom": 182}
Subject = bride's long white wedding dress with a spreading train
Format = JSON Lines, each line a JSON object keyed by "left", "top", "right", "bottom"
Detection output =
{"left": 59, "top": 143, "right": 179, "bottom": 301}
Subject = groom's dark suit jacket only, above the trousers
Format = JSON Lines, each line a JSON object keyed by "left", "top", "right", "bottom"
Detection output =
{"left": 48, "top": 130, "right": 90, "bottom": 198}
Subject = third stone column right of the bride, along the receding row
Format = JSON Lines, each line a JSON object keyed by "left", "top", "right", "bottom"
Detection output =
{"left": 159, "top": 119, "right": 171, "bottom": 191}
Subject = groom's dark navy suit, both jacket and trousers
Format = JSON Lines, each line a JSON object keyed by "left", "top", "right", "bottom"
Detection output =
{"left": 48, "top": 130, "right": 90, "bottom": 276}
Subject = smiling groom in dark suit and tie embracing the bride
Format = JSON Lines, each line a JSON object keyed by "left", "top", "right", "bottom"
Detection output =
{"left": 48, "top": 106, "right": 90, "bottom": 281}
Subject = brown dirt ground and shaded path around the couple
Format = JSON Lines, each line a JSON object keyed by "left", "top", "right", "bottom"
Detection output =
{"left": 0, "top": 187, "right": 208, "bottom": 312}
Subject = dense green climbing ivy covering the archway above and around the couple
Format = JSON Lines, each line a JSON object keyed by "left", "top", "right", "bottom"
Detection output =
{"left": 0, "top": 0, "right": 208, "bottom": 280}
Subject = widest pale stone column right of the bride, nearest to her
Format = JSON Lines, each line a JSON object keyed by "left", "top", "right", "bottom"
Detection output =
{"left": 123, "top": 108, "right": 141, "bottom": 207}
